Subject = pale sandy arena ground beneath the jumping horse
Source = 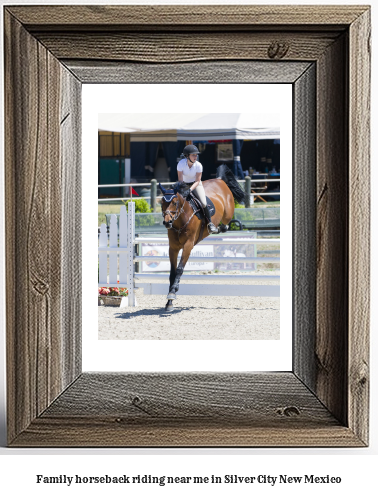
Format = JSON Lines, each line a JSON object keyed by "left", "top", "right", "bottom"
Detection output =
{"left": 98, "top": 271, "right": 280, "bottom": 340}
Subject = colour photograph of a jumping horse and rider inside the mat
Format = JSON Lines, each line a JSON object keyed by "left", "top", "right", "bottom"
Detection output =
{"left": 98, "top": 112, "right": 284, "bottom": 340}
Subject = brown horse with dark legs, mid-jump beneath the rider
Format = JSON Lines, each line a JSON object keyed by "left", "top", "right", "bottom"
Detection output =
{"left": 159, "top": 165, "right": 245, "bottom": 312}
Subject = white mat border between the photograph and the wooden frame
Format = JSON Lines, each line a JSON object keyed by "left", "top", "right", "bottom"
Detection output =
{"left": 82, "top": 84, "right": 292, "bottom": 371}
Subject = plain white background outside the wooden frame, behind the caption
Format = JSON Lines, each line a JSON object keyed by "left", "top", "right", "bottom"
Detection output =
{"left": 0, "top": 0, "right": 378, "bottom": 500}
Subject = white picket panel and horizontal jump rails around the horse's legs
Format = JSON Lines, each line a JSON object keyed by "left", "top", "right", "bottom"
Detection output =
{"left": 98, "top": 203, "right": 280, "bottom": 306}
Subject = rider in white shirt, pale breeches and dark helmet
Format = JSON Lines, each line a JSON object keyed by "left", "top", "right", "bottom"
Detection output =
{"left": 177, "top": 144, "right": 218, "bottom": 233}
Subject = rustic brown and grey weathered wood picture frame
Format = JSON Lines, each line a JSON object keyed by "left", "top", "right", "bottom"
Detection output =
{"left": 4, "top": 6, "right": 370, "bottom": 446}
